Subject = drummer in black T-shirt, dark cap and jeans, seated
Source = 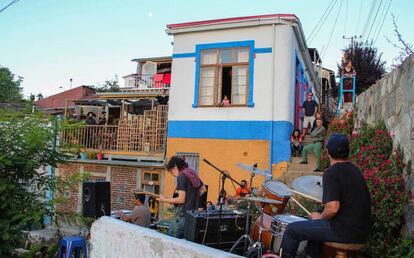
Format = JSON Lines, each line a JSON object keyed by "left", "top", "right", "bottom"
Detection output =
{"left": 281, "top": 134, "right": 372, "bottom": 258}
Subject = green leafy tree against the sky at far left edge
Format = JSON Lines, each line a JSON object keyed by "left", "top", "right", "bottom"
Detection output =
{"left": 0, "top": 66, "right": 23, "bottom": 102}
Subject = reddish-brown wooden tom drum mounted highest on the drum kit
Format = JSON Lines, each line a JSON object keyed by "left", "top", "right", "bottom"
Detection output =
{"left": 258, "top": 180, "right": 292, "bottom": 215}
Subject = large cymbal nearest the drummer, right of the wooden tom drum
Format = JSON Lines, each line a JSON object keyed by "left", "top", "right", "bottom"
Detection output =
{"left": 292, "top": 176, "right": 323, "bottom": 200}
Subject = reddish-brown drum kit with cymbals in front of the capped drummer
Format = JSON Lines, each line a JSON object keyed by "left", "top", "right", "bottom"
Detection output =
{"left": 230, "top": 164, "right": 322, "bottom": 257}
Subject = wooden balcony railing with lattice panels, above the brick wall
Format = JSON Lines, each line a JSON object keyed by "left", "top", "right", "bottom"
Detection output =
{"left": 61, "top": 105, "right": 168, "bottom": 157}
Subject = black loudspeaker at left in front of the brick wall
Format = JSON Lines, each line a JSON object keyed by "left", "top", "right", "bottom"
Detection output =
{"left": 82, "top": 182, "right": 111, "bottom": 218}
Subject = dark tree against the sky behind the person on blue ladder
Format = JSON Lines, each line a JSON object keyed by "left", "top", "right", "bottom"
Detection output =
{"left": 334, "top": 41, "right": 385, "bottom": 94}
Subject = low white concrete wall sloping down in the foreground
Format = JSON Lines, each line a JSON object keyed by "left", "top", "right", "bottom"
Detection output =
{"left": 91, "top": 217, "right": 241, "bottom": 258}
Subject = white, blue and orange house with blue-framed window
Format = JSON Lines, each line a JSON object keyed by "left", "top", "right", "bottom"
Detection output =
{"left": 164, "top": 14, "right": 321, "bottom": 202}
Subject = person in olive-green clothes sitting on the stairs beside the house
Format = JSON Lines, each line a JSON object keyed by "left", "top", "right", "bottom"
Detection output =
{"left": 300, "top": 119, "right": 326, "bottom": 172}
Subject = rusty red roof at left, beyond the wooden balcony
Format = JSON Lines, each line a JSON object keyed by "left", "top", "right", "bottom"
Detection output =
{"left": 35, "top": 85, "right": 95, "bottom": 110}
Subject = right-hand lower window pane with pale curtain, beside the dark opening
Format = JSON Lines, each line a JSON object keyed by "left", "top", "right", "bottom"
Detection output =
{"left": 231, "top": 65, "right": 248, "bottom": 105}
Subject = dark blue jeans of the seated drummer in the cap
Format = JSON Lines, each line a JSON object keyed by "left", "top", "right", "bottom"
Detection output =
{"left": 280, "top": 220, "right": 341, "bottom": 258}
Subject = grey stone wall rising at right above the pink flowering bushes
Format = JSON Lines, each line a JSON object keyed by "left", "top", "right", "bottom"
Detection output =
{"left": 357, "top": 55, "right": 414, "bottom": 230}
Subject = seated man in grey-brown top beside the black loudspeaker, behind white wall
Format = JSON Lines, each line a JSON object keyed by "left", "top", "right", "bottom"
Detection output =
{"left": 116, "top": 194, "right": 151, "bottom": 228}
